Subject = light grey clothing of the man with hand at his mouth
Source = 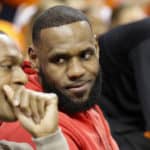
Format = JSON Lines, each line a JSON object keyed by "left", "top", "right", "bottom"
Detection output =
{"left": 0, "top": 129, "right": 69, "bottom": 150}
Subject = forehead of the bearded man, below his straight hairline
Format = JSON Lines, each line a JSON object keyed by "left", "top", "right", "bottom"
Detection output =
{"left": 40, "top": 21, "right": 94, "bottom": 52}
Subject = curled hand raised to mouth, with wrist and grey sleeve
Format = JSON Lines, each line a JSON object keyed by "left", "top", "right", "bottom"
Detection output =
{"left": 2, "top": 86, "right": 68, "bottom": 150}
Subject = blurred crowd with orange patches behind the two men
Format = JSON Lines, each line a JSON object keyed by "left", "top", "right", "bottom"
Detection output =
{"left": 0, "top": 0, "right": 150, "bottom": 58}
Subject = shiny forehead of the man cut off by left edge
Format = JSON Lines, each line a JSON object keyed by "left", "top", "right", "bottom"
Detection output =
{"left": 0, "top": 34, "right": 21, "bottom": 57}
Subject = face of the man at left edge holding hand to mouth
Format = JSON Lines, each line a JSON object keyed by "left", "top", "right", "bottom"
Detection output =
{"left": 0, "top": 34, "right": 27, "bottom": 120}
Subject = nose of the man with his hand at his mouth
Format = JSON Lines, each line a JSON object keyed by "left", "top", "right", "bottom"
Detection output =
{"left": 12, "top": 66, "right": 27, "bottom": 85}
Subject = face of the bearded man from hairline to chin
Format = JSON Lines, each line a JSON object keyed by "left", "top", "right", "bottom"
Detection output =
{"left": 37, "top": 21, "right": 99, "bottom": 103}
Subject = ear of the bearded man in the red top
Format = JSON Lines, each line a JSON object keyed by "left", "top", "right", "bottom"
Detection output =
{"left": 28, "top": 45, "right": 39, "bottom": 71}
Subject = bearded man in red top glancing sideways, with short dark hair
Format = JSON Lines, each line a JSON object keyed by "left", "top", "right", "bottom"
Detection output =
{"left": 27, "top": 6, "right": 118, "bottom": 150}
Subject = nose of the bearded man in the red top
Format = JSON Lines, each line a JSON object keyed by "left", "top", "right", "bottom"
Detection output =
{"left": 67, "top": 58, "right": 85, "bottom": 80}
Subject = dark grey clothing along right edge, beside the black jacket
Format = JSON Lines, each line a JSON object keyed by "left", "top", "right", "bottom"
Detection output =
{"left": 129, "top": 39, "right": 150, "bottom": 134}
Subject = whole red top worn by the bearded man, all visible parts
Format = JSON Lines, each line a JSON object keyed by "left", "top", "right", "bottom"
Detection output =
{"left": 0, "top": 61, "right": 118, "bottom": 150}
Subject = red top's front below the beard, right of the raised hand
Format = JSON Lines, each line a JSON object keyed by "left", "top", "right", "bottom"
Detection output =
{"left": 59, "top": 106, "right": 119, "bottom": 150}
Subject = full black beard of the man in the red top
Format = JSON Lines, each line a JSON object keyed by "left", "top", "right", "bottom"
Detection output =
{"left": 40, "top": 70, "right": 101, "bottom": 114}
